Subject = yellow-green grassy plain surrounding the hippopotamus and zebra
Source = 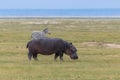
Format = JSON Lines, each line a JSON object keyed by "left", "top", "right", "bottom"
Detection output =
{"left": 0, "top": 18, "right": 120, "bottom": 80}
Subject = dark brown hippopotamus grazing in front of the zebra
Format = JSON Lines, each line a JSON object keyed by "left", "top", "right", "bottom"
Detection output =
{"left": 26, "top": 37, "right": 78, "bottom": 61}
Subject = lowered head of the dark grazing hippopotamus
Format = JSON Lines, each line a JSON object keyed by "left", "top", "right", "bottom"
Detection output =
{"left": 65, "top": 43, "right": 78, "bottom": 60}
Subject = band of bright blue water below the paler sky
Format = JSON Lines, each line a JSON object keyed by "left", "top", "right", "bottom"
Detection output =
{"left": 0, "top": 9, "right": 120, "bottom": 17}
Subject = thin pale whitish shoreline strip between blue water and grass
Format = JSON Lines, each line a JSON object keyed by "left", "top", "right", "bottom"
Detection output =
{"left": 0, "top": 16, "right": 120, "bottom": 19}
